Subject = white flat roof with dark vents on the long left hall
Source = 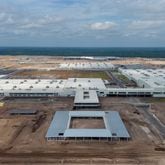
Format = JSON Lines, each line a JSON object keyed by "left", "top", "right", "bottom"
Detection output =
{"left": 0, "top": 78, "right": 106, "bottom": 93}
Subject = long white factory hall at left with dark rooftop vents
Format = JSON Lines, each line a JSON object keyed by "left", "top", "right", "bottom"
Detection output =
{"left": 0, "top": 78, "right": 106, "bottom": 97}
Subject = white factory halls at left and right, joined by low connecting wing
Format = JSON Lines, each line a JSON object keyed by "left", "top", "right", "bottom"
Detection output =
{"left": 0, "top": 69, "right": 165, "bottom": 97}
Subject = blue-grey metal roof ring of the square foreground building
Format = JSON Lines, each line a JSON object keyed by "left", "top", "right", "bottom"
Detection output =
{"left": 46, "top": 111, "right": 130, "bottom": 138}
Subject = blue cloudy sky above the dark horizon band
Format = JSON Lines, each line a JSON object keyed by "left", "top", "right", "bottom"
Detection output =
{"left": 0, "top": 0, "right": 165, "bottom": 47}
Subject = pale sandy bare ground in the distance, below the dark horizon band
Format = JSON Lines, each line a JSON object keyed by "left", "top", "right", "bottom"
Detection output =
{"left": 0, "top": 56, "right": 165, "bottom": 70}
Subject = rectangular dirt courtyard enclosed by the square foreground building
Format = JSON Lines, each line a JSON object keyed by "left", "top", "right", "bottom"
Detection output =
{"left": 70, "top": 118, "right": 105, "bottom": 129}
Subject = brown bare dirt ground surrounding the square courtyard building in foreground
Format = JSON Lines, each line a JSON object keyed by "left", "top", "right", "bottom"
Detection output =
{"left": 0, "top": 97, "right": 165, "bottom": 165}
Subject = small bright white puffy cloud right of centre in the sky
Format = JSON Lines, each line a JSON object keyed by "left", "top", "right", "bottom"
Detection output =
{"left": 90, "top": 21, "right": 117, "bottom": 30}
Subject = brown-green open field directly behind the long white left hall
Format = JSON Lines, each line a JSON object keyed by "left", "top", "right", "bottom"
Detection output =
{"left": 11, "top": 70, "right": 109, "bottom": 79}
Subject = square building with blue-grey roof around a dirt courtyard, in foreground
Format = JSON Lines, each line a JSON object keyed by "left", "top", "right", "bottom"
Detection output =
{"left": 46, "top": 111, "right": 130, "bottom": 141}
